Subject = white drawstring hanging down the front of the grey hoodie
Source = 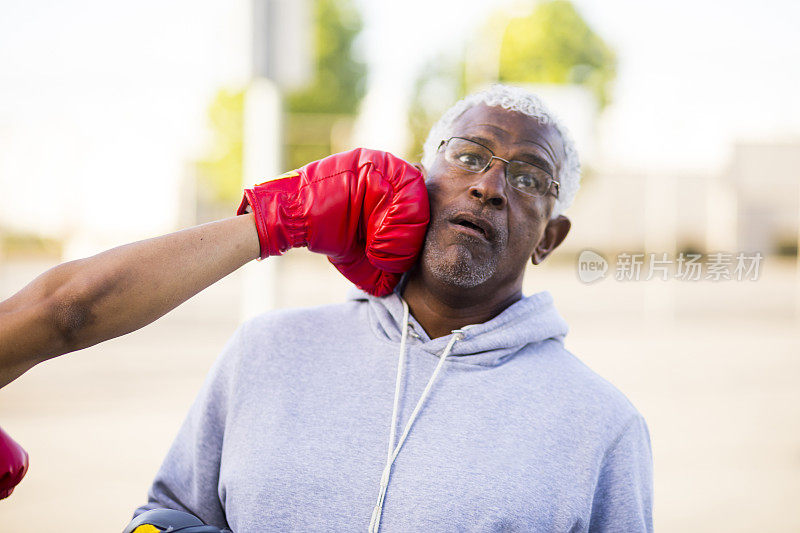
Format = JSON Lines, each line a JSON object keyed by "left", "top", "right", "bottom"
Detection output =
{"left": 369, "top": 298, "right": 463, "bottom": 533}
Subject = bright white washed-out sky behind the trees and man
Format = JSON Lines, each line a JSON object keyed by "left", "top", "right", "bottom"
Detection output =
{"left": 0, "top": 0, "right": 800, "bottom": 242}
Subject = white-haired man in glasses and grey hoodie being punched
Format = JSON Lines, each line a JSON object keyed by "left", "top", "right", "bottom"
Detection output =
{"left": 129, "top": 86, "right": 652, "bottom": 532}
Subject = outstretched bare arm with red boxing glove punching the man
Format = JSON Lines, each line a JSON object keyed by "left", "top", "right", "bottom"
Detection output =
{"left": 0, "top": 149, "right": 428, "bottom": 387}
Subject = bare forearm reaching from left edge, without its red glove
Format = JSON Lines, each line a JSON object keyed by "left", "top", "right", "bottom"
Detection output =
{"left": 0, "top": 214, "right": 259, "bottom": 387}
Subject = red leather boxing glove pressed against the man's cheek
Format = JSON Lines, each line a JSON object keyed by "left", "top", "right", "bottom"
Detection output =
{"left": 238, "top": 148, "right": 430, "bottom": 296}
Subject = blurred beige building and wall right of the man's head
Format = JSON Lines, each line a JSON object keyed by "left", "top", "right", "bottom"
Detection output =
{"left": 564, "top": 132, "right": 800, "bottom": 262}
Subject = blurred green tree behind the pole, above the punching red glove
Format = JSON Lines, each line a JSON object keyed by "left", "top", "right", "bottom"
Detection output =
{"left": 195, "top": 0, "right": 367, "bottom": 206}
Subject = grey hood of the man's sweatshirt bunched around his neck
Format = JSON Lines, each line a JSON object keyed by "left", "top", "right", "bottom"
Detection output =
{"left": 348, "top": 280, "right": 569, "bottom": 366}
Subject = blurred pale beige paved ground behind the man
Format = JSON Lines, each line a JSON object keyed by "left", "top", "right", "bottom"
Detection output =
{"left": 0, "top": 253, "right": 800, "bottom": 533}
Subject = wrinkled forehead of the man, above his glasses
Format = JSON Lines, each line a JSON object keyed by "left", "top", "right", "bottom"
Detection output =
{"left": 450, "top": 104, "right": 566, "bottom": 177}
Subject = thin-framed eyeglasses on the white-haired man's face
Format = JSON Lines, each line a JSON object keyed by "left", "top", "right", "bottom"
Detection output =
{"left": 438, "top": 137, "right": 561, "bottom": 198}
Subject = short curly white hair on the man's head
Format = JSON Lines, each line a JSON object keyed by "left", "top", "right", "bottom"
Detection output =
{"left": 422, "top": 84, "right": 581, "bottom": 218}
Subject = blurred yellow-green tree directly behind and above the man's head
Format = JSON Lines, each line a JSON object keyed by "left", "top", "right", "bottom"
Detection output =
{"left": 408, "top": 0, "right": 617, "bottom": 156}
